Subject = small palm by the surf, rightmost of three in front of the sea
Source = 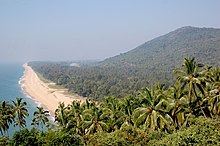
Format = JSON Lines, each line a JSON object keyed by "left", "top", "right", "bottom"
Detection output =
{"left": 31, "top": 107, "right": 50, "bottom": 130}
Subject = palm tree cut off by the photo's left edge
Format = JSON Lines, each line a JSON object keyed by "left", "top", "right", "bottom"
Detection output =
{"left": 0, "top": 101, "right": 14, "bottom": 135}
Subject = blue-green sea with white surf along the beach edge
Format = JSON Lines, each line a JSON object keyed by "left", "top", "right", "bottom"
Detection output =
{"left": 0, "top": 63, "right": 40, "bottom": 138}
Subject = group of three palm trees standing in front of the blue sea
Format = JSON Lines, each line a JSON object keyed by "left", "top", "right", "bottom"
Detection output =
{"left": 0, "top": 98, "right": 49, "bottom": 135}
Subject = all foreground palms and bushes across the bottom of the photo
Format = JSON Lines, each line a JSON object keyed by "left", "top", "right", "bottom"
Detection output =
{"left": 0, "top": 58, "right": 220, "bottom": 146}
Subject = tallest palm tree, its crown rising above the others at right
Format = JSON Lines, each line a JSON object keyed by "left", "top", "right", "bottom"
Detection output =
{"left": 175, "top": 58, "right": 206, "bottom": 117}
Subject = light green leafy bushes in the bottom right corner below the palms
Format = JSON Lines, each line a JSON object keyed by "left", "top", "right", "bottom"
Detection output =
{"left": 149, "top": 117, "right": 220, "bottom": 146}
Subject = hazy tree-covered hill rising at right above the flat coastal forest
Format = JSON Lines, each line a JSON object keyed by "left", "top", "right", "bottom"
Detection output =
{"left": 100, "top": 26, "right": 220, "bottom": 68}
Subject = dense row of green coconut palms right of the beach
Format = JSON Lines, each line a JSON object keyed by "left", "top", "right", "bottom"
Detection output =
{"left": 55, "top": 58, "right": 220, "bottom": 136}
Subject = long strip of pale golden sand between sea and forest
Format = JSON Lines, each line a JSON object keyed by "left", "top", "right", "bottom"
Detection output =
{"left": 21, "top": 64, "right": 84, "bottom": 116}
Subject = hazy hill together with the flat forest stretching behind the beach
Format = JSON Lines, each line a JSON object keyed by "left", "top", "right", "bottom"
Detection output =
{"left": 29, "top": 27, "right": 220, "bottom": 100}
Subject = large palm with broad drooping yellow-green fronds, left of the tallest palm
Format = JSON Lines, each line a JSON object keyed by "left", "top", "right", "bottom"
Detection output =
{"left": 133, "top": 88, "right": 172, "bottom": 130}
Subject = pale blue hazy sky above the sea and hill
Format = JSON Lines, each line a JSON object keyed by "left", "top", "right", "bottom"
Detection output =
{"left": 0, "top": 0, "right": 220, "bottom": 62}
